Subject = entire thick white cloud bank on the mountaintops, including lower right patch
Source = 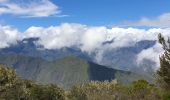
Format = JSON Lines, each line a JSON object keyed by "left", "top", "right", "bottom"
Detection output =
{"left": 0, "top": 23, "right": 170, "bottom": 66}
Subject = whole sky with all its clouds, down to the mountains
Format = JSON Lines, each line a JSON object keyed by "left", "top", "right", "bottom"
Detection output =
{"left": 0, "top": 0, "right": 170, "bottom": 66}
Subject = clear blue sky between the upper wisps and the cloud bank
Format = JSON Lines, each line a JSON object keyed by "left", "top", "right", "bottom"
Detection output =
{"left": 0, "top": 0, "right": 170, "bottom": 31}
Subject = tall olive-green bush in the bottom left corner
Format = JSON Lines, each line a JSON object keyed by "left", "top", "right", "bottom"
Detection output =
{"left": 0, "top": 65, "right": 29, "bottom": 100}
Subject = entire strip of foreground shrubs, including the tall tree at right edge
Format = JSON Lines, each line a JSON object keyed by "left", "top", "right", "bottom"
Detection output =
{"left": 0, "top": 35, "right": 170, "bottom": 100}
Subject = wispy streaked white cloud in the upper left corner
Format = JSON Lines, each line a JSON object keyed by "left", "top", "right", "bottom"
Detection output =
{"left": 0, "top": 0, "right": 61, "bottom": 17}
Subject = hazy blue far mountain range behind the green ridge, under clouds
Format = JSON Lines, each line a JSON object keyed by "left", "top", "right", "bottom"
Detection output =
{"left": 0, "top": 38, "right": 156, "bottom": 74}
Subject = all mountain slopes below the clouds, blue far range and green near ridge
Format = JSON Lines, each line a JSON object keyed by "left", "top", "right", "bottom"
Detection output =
{"left": 0, "top": 38, "right": 156, "bottom": 87}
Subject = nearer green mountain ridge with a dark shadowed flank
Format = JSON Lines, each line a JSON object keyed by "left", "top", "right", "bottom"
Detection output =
{"left": 0, "top": 53, "right": 153, "bottom": 88}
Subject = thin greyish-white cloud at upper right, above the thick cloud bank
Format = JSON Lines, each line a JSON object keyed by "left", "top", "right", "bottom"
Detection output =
{"left": 122, "top": 13, "right": 170, "bottom": 27}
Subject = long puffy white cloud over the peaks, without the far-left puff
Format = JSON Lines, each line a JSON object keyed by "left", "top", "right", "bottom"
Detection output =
{"left": 24, "top": 23, "right": 170, "bottom": 53}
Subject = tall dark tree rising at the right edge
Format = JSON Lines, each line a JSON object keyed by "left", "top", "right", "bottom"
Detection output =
{"left": 157, "top": 34, "right": 170, "bottom": 91}
